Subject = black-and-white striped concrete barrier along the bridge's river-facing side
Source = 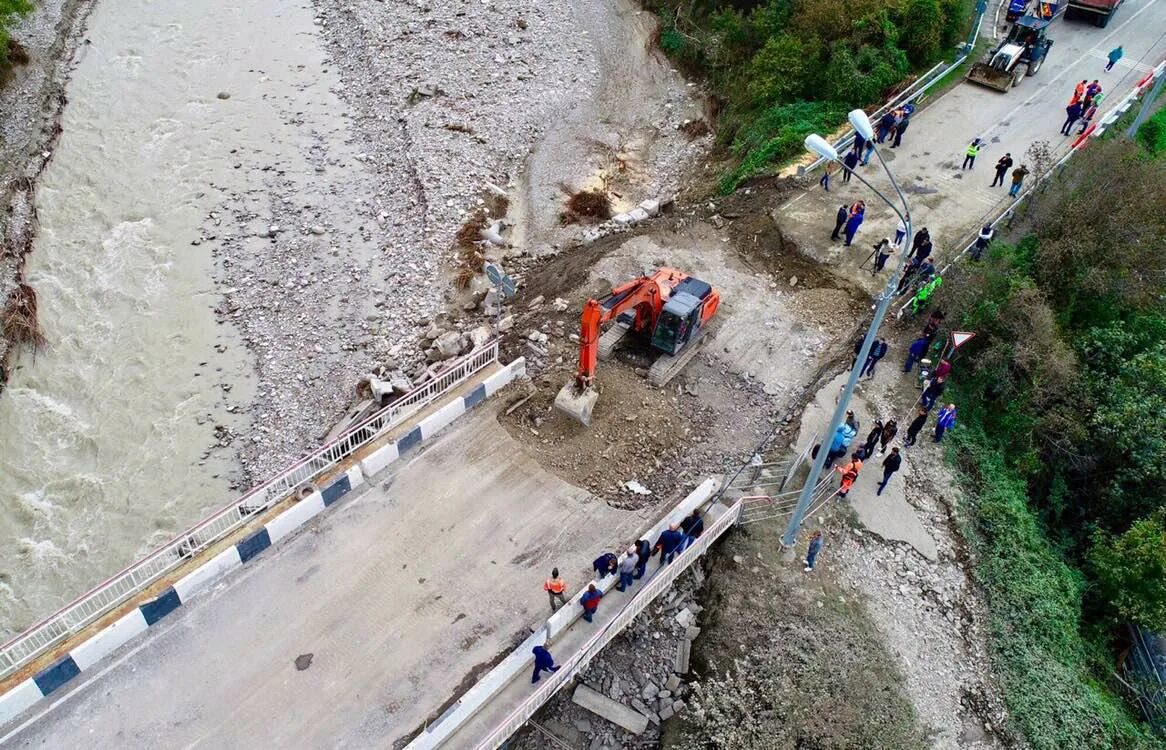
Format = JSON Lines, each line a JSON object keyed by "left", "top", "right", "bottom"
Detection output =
{"left": 0, "top": 357, "right": 526, "bottom": 727}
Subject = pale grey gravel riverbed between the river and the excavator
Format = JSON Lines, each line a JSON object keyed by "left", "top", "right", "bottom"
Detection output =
{"left": 204, "top": 0, "right": 707, "bottom": 483}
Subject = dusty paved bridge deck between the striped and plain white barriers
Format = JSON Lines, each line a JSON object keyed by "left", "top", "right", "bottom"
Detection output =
{"left": 0, "top": 405, "right": 647, "bottom": 749}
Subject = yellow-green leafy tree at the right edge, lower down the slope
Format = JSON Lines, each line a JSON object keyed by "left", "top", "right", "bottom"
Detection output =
{"left": 1090, "top": 511, "right": 1166, "bottom": 631}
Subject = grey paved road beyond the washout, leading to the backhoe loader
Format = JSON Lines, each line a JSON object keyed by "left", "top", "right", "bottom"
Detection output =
{"left": 774, "top": 0, "right": 1166, "bottom": 292}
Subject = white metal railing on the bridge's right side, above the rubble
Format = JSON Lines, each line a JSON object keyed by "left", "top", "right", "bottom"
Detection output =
{"left": 468, "top": 500, "right": 742, "bottom": 750}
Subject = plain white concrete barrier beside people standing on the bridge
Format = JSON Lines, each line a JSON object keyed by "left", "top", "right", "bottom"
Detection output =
{"left": 406, "top": 477, "right": 721, "bottom": 750}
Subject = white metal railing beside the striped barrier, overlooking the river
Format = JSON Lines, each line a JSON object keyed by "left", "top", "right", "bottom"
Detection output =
{"left": 0, "top": 338, "right": 499, "bottom": 678}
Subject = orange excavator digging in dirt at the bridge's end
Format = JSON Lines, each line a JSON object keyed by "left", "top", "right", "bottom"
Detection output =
{"left": 555, "top": 268, "right": 721, "bottom": 425}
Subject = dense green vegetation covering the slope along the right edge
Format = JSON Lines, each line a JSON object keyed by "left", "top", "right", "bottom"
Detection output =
{"left": 940, "top": 140, "right": 1166, "bottom": 750}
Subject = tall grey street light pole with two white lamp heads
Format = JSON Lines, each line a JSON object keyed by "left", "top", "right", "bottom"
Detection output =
{"left": 781, "top": 117, "right": 911, "bottom": 548}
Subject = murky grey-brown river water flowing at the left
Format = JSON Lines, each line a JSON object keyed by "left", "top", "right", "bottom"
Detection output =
{"left": 0, "top": 0, "right": 340, "bottom": 637}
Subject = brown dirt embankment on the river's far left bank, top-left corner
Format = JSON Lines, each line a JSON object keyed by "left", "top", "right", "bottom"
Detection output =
{"left": 0, "top": 0, "right": 93, "bottom": 391}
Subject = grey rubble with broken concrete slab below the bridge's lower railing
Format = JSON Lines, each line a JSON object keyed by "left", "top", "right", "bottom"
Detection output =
{"left": 517, "top": 560, "right": 704, "bottom": 750}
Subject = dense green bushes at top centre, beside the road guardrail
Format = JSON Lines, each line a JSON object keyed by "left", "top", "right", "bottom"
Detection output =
{"left": 645, "top": 0, "right": 970, "bottom": 191}
